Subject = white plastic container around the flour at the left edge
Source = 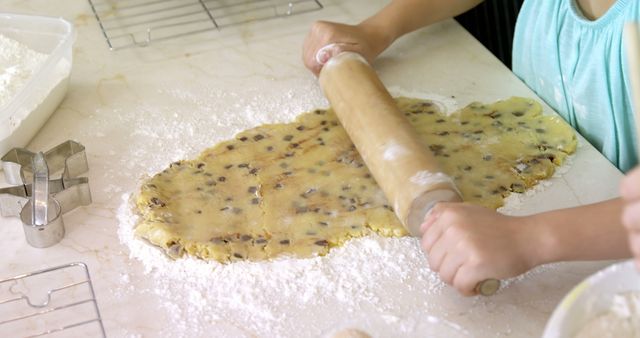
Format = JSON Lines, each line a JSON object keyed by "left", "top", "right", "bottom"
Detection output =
{"left": 0, "top": 13, "right": 76, "bottom": 156}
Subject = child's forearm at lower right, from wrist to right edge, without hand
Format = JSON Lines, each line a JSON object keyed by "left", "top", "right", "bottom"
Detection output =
{"left": 527, "top": 198, "right": 631, "bottom": 265}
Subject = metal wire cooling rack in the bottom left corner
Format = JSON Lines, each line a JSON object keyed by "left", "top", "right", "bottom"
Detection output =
{"left": 0, "top": 263, "right": 106, "bottom": 337}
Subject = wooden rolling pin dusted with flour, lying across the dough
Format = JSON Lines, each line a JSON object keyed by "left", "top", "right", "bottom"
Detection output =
{"left": 319, "top": 52, "right": 500, "bottom": 295}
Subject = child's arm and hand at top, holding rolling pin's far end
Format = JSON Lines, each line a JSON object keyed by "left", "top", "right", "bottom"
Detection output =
{"left": 302, "top": 0, "right": 482, "bottom": 75}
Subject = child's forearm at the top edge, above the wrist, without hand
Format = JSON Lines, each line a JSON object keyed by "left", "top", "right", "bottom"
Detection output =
{"left": 359, "top": 0, "right": 483, "bottom": 46}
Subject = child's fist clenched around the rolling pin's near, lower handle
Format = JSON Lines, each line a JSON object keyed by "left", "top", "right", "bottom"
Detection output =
{"left": 421, "top": 203, "right": 537, "bottom": 296}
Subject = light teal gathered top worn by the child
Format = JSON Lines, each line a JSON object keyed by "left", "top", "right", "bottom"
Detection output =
{"left": 513, "top": 0, "right": 640, "bottom": 172}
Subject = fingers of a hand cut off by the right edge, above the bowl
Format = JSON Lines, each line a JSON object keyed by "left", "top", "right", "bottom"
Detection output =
{"left": 620, "top": 167, "right": 640, "bottom": 269}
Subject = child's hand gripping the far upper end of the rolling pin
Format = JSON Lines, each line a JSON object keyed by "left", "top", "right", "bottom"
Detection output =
{"left": 302, "top": 21, "right": 391, "bottom": 76}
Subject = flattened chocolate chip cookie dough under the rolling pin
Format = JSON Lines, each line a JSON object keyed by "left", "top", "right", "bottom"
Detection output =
{"left": 135, "top": 98, "right": 576, "bottom": 263}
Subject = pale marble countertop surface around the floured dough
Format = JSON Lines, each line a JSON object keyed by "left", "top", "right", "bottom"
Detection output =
{"left": 0, "top": 0, "right": 621, "bottom": 337}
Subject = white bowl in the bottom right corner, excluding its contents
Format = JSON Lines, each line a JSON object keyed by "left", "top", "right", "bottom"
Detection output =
{"left": 543, "top": 260, "right": 640, "bottom": 338}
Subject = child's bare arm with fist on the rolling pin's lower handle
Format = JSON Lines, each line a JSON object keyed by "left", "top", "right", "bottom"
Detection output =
{"left": 422, "top": 199, "right": 631, "bottom": 295}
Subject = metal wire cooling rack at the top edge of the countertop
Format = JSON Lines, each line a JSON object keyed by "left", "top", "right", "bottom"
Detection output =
{"left": 88, "top": 0, "right": 322, "bottom": 50}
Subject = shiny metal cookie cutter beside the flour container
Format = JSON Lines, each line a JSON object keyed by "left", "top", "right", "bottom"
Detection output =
{"left": 0, "top": 141, "right": 91, "bottom": 248}
